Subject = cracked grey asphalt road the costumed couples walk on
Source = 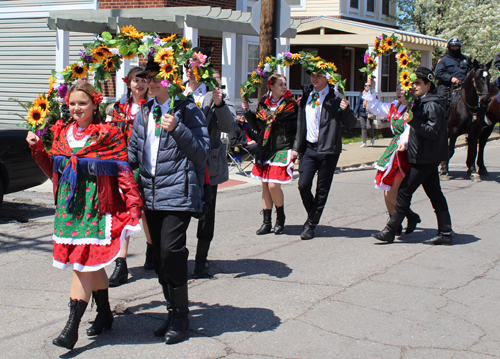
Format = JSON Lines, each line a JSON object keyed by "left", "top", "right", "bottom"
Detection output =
{"left": 0, "top": 141, "right": 500, "bottom": 359}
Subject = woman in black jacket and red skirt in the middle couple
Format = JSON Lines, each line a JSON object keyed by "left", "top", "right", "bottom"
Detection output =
{"left": 242, "top": 74, "right": 298, "bottom": 235}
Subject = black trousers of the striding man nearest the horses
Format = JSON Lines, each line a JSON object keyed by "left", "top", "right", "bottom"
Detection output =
{"left": 396, "top": 163, "right": 448, "bottom": 214}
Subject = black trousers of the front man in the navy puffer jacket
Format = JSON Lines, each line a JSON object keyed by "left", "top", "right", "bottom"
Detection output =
{"left": 145, "top": 210, "right": 191, "bottom": 288}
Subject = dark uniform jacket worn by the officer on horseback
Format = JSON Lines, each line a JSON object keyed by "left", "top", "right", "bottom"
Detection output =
{"left": 434, "top": 50, "right": 474, "bottom": 99}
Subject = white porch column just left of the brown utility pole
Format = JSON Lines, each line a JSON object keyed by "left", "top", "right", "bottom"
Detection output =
{"left": 221, "top": 31, "right": 239, "bottom": 100}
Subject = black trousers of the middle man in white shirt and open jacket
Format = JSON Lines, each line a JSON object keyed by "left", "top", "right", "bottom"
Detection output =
{"left": 299, "top": 143, "right": 340, "bottom": 217}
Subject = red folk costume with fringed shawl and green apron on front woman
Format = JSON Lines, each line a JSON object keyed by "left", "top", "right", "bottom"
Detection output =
{"left": 30, "top": 120, "right": 143, "bottom": 272}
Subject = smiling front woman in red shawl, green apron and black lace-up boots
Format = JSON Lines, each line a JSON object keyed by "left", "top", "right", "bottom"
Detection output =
{"left": 26, "top": 82, "right": 143, "bottom": 349}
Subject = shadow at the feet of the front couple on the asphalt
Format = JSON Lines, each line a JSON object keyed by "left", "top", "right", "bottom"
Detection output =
{"left": 60, "top": 301, "right": 281, "bottom": 358}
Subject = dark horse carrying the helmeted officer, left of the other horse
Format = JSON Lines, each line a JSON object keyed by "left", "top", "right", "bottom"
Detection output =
{"left": 441, "top": 60, "right": 492, "bottom": 182}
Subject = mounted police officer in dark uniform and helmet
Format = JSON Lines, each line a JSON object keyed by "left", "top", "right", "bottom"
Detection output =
{"left": 435, "top": 36, "right": 474, "bottom": 107}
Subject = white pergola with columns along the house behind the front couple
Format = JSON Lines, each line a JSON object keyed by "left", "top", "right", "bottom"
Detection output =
{"left": 47, "top": 6, "right": 300, "bottom": 99}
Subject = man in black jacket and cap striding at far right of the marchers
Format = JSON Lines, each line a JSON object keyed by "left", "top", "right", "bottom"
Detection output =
{"left": 372, "top": 67, "right": 452, "bottom": 245}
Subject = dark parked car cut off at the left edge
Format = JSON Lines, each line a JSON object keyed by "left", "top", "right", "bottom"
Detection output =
{"left": 0, "top": 124, "right": 47, "bottom": 206}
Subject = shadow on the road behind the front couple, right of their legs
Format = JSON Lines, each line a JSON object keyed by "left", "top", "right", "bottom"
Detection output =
{"left": 201, "top": 259, "right": 292, "bottom": 278}
